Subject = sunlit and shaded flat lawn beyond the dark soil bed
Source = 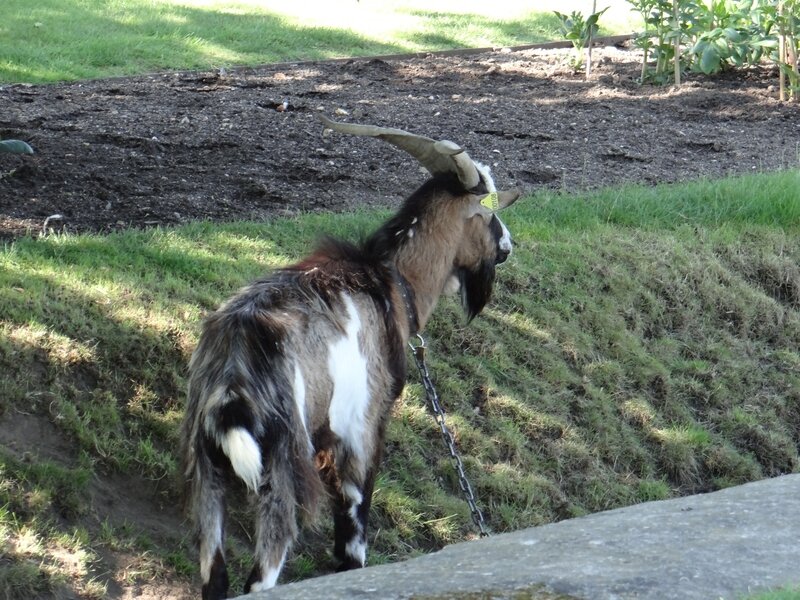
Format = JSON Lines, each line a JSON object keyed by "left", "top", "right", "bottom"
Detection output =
{"left": 0, "top": 0, "right": 632, "bottom": 83}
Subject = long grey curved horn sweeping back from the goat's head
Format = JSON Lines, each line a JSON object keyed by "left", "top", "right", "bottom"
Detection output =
{"left": 317, "top": 113, "right": 481, "bottom": 190}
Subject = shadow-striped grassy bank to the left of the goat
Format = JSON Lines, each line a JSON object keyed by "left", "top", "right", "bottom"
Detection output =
{"left": 0, "top": 228, "right": 300, "bottom": 597}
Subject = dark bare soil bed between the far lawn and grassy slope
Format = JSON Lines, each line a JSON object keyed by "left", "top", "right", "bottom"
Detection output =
{"left": 0, "top": 47, "right": 800, "bottom": 238}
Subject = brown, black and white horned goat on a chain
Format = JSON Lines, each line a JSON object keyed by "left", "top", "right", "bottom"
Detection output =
{"left": 181, "top": 117, "right": 520, "bottom": 600}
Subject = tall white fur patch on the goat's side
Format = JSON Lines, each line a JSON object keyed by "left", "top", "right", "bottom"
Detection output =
{"left": 328, "top": 294, "right": 369, "bottom": 461}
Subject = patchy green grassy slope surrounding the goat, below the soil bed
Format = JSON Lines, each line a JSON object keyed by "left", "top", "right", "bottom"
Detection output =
{"left": 0, "top": 171, "right": 800, "bottom": 597}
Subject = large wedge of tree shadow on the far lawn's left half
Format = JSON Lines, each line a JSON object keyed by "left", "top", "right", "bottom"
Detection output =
{"left": 0, "top": 3, "right": 404, "bottom": 82}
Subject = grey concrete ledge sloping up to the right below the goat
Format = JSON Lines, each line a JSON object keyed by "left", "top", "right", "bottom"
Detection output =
{"left": 242, "top": 475, "right": 800, "bottom": 600}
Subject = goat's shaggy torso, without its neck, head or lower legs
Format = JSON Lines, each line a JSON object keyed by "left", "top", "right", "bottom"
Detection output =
{"left": 183, "top": 247, "right": 406, "bottom": 511}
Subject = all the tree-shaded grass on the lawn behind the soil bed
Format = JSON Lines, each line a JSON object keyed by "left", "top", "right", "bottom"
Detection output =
{"left": 0, "top": 0, "right": 558, "bottom": 82}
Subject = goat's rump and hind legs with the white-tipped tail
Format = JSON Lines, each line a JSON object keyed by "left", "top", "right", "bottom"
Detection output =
{"left": 182, "top": 373, "right": 323, "bottom": 598}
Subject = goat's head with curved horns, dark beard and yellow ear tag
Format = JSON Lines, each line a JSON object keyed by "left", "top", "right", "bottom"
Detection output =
{"left": 319, "top": 115, "right": 520, "bottom": 321}
